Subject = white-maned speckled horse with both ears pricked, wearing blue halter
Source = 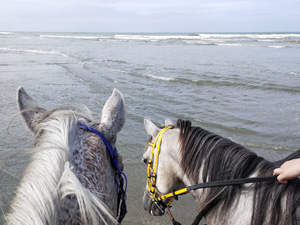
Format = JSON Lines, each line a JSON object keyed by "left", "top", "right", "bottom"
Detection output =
{"left": 6, "top": 87, "right": 125, "bottom": 225}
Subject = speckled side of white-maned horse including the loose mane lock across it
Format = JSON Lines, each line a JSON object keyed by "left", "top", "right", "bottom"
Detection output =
{"left": 54, "top": 116, "right": 117, "bottom": 224}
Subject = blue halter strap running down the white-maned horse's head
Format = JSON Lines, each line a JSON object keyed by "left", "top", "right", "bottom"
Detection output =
{"left": 78, "top": 124, "right": 127, "bottom": 224}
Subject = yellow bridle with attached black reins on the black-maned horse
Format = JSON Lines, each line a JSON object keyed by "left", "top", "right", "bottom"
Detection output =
{"left": 147, "top": 126, "right": 277, "bottom": 225}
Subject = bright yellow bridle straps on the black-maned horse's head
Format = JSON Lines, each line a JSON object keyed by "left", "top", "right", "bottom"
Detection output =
{"left": 147, "top": 126, "right": 189, "bottom": 208}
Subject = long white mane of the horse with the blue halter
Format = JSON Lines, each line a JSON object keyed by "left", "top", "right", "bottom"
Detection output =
{"left": 6, "top": 107, "right": 118, "bottom": 225}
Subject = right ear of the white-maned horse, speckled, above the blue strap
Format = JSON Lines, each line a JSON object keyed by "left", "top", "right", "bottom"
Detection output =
{"left": 101, "top": 88, "right": 126, "bottom": 135}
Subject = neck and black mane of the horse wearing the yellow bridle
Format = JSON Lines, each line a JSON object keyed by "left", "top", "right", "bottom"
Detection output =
{"left": 180, "top": 123, "right": 300, "bottom": 225}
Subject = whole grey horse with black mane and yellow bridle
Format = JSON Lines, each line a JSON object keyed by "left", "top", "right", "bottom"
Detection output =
{"left": 143, "top": 118, "right": 300, "bottom": 225}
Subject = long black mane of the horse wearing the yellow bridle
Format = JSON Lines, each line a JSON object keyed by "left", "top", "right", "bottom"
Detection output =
{"left": 177, "top": 120, "right": 300, "bottom": 225}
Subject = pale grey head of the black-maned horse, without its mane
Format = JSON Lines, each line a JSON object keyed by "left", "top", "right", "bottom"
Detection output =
{"left": 143, "top": 118, "right": 184, "bottom": 216}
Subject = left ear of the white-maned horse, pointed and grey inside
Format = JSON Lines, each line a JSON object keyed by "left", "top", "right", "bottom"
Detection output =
{"left": 17, "top": 87, "right": 46, "bottom": 132}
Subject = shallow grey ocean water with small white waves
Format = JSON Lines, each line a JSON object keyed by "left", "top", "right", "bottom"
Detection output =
{"left": 0, "top": 32, "right": 300, "bottom": 225}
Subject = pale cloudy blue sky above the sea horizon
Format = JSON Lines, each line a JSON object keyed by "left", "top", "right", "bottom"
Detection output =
{"left": 0, "top": 0, "right": 300, "bottom": 32}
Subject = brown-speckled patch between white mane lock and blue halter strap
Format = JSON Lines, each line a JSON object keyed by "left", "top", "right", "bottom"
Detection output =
{"left": 70, "top": 126, "right": 117, "bottom": 214}
